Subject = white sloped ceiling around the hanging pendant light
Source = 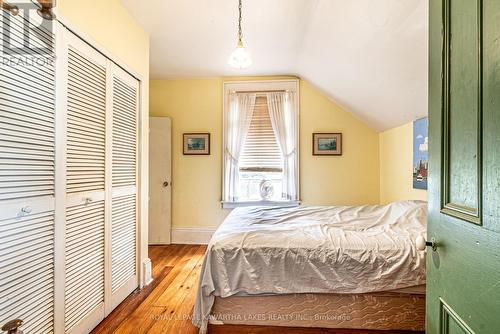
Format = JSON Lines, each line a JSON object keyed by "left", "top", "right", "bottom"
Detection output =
{"left": 122, "top": 0, "right": 428, "bottom": 130}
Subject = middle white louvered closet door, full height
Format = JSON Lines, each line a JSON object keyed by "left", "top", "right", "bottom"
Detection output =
{"left": 64, "top": 32, "right": 107, "bottom": 333}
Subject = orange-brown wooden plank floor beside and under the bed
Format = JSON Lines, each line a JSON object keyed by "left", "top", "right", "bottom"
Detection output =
{"left": 92, "top": 245, "right": 424, "bottom": 334}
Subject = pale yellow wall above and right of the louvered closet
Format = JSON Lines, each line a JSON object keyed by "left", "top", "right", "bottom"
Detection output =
{"left": 56, "top": 0, "right": 149, "bottom": 276}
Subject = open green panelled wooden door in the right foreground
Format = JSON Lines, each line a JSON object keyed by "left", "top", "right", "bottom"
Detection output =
{"left": 427, "top": 0, "right": 500, "bottom": 334}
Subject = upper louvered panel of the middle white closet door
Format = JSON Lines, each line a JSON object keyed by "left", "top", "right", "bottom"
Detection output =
{"left": 66, "top": 47, "right": 106, "bottom": 194}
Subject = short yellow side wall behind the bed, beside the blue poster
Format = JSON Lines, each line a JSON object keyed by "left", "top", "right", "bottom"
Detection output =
{"left": 380, "top": 123, "right": 427, "bottom": 203}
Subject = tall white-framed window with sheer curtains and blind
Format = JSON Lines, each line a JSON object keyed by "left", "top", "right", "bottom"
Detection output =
{"left": 223, "top": 81, "right": 298, "bottom": 207}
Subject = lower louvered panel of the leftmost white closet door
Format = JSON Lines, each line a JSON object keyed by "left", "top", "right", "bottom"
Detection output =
{"left": 0, "top": 211, "right": 54, "bottom": 333}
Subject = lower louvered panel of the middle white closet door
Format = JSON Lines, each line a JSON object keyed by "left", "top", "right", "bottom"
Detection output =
{"left": 65, "top": 201, "right": 104, "bottom": 331}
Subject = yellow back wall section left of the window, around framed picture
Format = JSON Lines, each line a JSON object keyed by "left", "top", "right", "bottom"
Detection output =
{"left": 150, "top": 79, "right": 228, "bottom": 227}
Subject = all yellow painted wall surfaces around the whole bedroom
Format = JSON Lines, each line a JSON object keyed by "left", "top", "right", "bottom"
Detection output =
{"left": 57, "top": 0, "right": 427, "bottom": 232}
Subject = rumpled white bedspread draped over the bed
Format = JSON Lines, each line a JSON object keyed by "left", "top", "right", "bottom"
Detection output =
{"left": 193, "top": 201, "right": 427, "bottom": 333}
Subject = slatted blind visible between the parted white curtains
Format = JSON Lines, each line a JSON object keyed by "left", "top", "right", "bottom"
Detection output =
{"left": 240, "top": 96, "right": 283, "bottom": 172}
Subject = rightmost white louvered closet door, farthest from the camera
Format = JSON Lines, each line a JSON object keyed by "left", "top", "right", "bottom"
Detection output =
{"left": 106, "top": 64, "right": 139, "bottom": 313}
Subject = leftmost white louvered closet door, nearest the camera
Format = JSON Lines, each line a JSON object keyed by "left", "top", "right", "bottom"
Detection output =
{"left": 0, "top": 5, "right": 55, "bottom": 334}
